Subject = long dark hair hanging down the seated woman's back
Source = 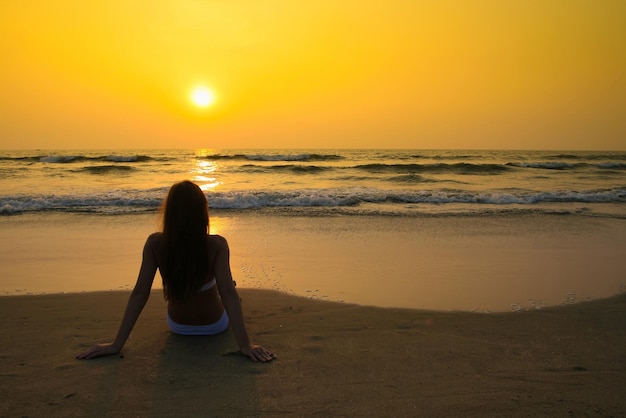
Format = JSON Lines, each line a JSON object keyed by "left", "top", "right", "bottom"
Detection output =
{"left": 160, "top": 181, "right": 209, "bottom": 302}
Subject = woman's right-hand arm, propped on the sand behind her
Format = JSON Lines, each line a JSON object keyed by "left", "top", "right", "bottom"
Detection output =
{"left": 214, "top": 236, "right": 276, "bottom": 362}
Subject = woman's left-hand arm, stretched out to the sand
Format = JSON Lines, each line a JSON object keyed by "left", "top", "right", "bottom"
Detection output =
{"left": 76, "top": 235, "right": 157, "bottom": 359}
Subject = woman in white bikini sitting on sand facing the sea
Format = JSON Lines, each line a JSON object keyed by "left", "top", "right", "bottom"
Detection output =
{"left": 76, "top": 181, "right": 275, "bottom": 362}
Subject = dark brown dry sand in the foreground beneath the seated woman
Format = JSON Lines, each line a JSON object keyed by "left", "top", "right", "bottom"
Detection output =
{"left": 0, "top": 289, "right": 626, "bottom": 417}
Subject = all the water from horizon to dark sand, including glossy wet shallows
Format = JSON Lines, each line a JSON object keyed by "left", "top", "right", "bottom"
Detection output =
{"left": 0, "top": 149, "right": 626, "bottom": 312}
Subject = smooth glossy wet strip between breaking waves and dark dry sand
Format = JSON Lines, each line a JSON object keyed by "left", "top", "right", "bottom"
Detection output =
{"left": 0, "top": 213, "right": 626, "bottom": 311}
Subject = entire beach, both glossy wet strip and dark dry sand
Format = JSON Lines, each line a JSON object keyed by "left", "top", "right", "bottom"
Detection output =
{"left": 0, "top": 214, "right": 626, "bottom": 417}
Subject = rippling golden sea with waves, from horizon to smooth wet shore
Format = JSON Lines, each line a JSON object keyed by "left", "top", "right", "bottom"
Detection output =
{"left": 0, "top": 149, "right": 626, "bottom": 218}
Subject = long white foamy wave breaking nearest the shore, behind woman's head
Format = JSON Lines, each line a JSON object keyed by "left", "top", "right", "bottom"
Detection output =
{"left": 0, "top": 188, "right": 626, "bottom": 215}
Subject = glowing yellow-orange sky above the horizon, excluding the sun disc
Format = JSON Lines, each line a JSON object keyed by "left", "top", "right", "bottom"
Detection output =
{"left": 0, "top": 0, "right": 626, "bottom": 150}
